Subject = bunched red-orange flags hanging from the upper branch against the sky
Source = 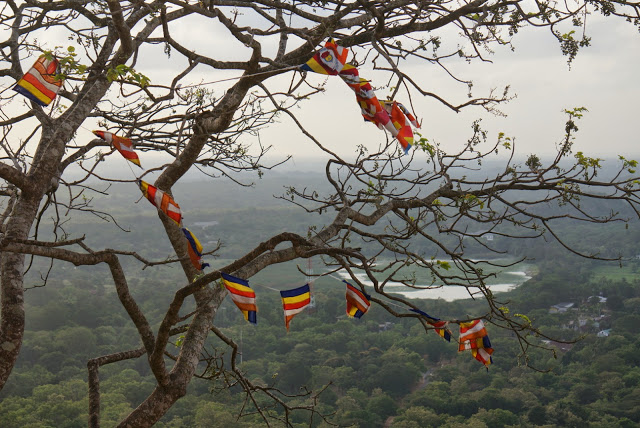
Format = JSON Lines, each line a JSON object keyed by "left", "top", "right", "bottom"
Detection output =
{"left": 299, "top": 39, "right": 420, "bottom": 153}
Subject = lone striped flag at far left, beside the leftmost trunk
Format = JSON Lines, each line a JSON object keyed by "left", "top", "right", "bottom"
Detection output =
{"left": 13, "top": 55, "right": 62, "bottom": 107}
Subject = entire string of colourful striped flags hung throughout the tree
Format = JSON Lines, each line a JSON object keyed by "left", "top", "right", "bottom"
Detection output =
{"left": 13, "top": 46, "right": 484, "bottom": 368}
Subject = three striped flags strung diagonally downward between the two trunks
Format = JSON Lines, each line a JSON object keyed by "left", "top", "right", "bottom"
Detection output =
{"left": 93, "top": 131, "right": 209, "bottom": 271}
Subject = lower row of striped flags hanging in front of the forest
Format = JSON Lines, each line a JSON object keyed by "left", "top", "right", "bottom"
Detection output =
{"left": 220, "top": 272, "right": 493, "bottom": 368}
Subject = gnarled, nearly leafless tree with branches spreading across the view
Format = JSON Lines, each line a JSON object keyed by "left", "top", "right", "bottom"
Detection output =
{"left": 0, "top": 0, "right": 638, "bottom": 427}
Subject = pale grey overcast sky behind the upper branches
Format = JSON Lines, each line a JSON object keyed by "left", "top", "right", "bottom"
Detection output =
{"left": 3, "top": 6, "right": 640, "bottom": 176}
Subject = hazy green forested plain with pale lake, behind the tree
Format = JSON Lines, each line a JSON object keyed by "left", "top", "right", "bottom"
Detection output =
{"left": 0, "top": 169, "right": 640, "bottom": 428}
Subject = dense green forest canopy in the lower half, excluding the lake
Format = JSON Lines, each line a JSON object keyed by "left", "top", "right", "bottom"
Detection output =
{"left": 0, "top": 241, "right": 640, "bottom": 428}
